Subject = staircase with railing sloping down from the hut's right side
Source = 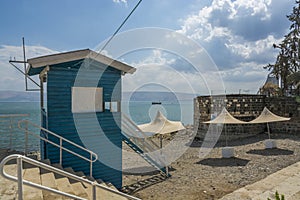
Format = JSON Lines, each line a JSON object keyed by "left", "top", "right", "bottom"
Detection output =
{"left": 121, "top": 114, "right": 170, "bottom": 177}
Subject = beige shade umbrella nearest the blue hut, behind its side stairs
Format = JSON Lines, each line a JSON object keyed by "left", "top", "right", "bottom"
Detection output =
{"left": 138, "top": 111, "right": 185, "bottom": 147}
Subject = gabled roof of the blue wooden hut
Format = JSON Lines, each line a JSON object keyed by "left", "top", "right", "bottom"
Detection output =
{"left": 27, "top": 49, "right": 136, "bottom": 76}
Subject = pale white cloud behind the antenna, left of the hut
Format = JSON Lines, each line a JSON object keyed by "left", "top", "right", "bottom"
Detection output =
{"left": 0, "top": 45, "right": 57, "bottom": 91}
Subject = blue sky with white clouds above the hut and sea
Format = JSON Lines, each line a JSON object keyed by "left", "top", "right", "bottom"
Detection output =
{"left": 0, "top": 0, "right": 295, "bottom": 94}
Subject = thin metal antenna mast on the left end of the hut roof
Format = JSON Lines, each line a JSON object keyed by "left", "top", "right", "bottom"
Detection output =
{"left": 9, "top": 37, "right": 41, "bottom": 91}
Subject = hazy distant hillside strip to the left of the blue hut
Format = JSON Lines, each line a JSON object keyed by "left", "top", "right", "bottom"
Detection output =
{"left": 0, "top": 91, "right": 40, "bottom": 102}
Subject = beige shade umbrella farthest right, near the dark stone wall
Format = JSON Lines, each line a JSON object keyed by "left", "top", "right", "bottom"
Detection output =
{"left": 249, "top": 107, "right": 291, "bottom": 139}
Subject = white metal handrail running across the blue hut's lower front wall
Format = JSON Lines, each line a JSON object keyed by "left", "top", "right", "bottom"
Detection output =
{"left": 18, "top": 120, "right": 98, "bottom": 177}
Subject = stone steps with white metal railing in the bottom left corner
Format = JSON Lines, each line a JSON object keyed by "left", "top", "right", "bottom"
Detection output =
{"left": 0, "top": 154, "right": 138, "bottom": 200}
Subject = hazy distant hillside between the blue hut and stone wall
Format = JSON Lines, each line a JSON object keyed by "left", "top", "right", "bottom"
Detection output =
{"left": 122, "top": 92, "right": 197, "bottom": 102}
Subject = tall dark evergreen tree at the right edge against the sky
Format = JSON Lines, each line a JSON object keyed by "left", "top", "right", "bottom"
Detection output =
{"left": 264, "top": 0, "right": 300, "bottom": 95}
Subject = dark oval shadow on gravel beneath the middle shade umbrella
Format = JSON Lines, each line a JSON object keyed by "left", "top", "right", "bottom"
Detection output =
{"left": 196, "top": 157, "right": 249, "bottom": 167}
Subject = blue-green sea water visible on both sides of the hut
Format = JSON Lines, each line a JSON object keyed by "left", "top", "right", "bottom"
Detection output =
{"left": 0, "top": 101, "right": 194, "bottom": 151}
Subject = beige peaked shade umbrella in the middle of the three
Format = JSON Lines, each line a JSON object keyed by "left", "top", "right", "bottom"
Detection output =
{"left": 203, "top": 108, "right": 247, "bottom": 146}
